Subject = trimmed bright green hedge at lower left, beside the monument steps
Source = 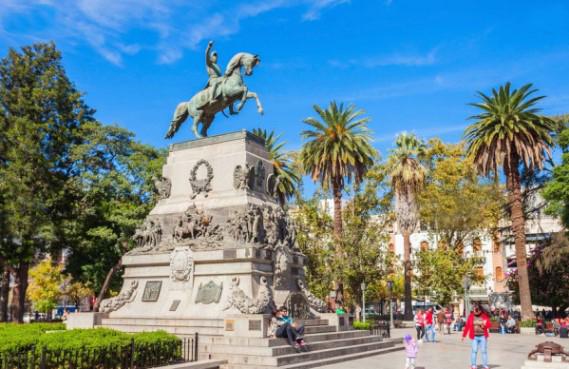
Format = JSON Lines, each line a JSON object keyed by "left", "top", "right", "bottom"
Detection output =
{"left": 0, "top": 324, "right": 182, "bottom": 368}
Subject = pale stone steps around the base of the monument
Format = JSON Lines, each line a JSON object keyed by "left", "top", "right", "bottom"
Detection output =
{"left": 102, "top": 318, "right": 403, "bottom": 369}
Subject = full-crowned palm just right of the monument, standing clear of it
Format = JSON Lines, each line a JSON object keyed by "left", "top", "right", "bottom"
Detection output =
{"left": 300, "top": 101, "right": 377, "bottom": 237}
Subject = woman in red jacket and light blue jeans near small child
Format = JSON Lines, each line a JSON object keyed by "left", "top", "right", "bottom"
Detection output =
{"left": 462, "top": 305, "right": 492, "bottom": 369}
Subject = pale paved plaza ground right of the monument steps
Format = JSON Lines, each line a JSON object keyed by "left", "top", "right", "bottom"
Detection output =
{"left": 322, "top": 329, "right": 569, "bottom": 369}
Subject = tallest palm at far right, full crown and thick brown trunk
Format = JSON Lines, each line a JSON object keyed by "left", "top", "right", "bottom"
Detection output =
{"left": 465, "top": 82, "right": 556, "bottom": 319}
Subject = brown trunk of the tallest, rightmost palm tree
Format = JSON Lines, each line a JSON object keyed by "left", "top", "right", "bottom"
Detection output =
{"left": 505, "top": 158, "right": 535, "bottom": 320}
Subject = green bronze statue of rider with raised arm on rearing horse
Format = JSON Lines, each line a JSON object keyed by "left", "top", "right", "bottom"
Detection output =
{"left": 166, "top": 41, "right": 263, "bottom": 138}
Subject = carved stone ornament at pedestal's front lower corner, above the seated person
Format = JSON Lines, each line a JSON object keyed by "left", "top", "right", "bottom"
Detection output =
{"left": 223, "top": 276, "right": 274, "bottom": 314}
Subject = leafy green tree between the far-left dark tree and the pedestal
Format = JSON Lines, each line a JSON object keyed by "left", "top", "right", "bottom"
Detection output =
{"left": 66, "top": 122, "right": 166, "bottom": 308}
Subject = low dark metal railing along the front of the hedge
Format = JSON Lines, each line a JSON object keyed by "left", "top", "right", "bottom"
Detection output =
{"left": 0, "top": 333, "right": 198, "bottom": 369}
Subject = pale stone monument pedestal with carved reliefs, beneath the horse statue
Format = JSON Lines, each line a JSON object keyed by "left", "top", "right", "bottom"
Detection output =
{"left": 101, "top": 131, "right": 324, "bottom": 326}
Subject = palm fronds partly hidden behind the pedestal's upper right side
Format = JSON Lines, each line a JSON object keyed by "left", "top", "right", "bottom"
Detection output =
{"left": 253, "top": 128, "right": 300, "bottom": 206}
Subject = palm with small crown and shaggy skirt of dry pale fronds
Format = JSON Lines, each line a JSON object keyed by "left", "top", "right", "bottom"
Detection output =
{"left": 388, "top": 133, "right": 426, "bottom": 320}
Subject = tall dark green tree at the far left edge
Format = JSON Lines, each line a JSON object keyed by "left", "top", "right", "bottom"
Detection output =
{"left": 0, "top": 43, "right": 93, "bottom": 321}
